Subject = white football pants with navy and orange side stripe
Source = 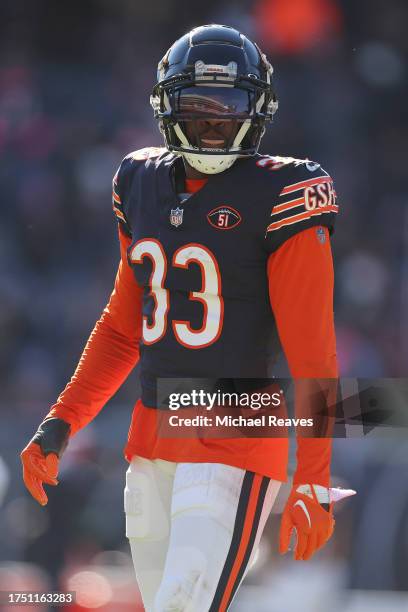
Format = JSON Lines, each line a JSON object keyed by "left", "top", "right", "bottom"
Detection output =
{"left": 125, "top": 457, "right": 281, "bottom": 612}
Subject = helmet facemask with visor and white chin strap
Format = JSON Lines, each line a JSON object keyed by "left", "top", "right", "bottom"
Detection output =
{"left": 151, "top": 61, "right": 277, "bottom": 174}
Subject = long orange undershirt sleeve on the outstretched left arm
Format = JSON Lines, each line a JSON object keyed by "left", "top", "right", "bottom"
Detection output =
{"left": 46, "top": 230, "right": 142, "bottom": 435}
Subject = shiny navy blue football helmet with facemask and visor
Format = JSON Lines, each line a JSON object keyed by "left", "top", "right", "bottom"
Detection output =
{"left": 150, "top": 24, "right": 278, "bottom": 174}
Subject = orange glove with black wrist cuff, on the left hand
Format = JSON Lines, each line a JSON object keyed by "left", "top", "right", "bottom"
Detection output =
{"left": 20, "top": 419, "right": 70, "bottom": 506}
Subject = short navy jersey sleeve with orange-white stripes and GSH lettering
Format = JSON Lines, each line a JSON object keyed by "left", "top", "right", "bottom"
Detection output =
{"left": 259, "top": 157, "right": 339, "bottom": 250}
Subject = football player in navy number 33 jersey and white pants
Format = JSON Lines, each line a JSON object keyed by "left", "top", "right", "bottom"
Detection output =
{"left": 22, "top": 24, "right": 352, "bottom": 612}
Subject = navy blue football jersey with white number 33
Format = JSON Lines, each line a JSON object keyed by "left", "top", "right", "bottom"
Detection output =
{"left": 113, "top": 149, "right": 337, "bottom": 406}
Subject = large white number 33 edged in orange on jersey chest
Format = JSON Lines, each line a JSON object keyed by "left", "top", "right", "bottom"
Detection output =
{"left": 130, "top": 238, "right": 224, "bottom": 349}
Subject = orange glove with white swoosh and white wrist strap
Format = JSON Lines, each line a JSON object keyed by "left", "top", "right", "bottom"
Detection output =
{"left": 279, "top": 485, "right": 355, "bottom": 561}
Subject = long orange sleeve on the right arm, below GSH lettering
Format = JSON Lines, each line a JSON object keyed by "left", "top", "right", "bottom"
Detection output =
{"left": 268, "top": 227, "right": 338, "bottom": 487}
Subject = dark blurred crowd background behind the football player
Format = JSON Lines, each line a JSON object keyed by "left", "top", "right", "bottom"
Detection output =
{"left": 0, "top": 0, "right": 408, "bottom": 612}
